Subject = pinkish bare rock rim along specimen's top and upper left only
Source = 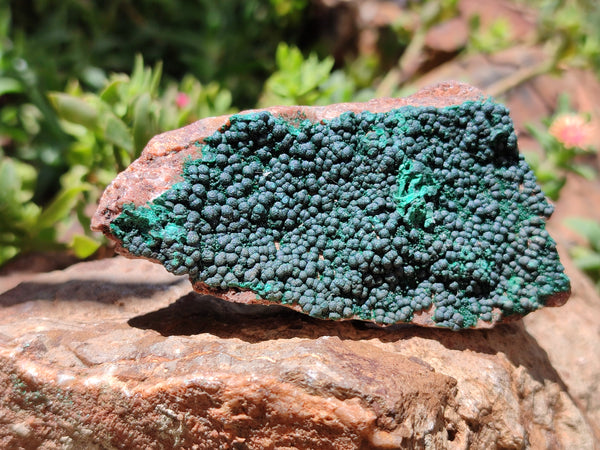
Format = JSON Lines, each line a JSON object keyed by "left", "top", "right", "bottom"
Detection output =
{"left": 92, "top": 82, "right": 483, "bottom": 236}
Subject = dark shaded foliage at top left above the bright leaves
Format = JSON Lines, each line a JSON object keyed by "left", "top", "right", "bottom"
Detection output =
{"left": 7, "top": 0, "right": 308, "bottom": 107}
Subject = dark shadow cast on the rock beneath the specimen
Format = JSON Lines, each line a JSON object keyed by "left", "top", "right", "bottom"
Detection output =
{"left": 128, "top": 293, "right": 566, "bottom": 389}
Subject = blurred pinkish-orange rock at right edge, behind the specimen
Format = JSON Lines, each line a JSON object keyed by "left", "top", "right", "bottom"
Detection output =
{"left": 524, "top": 175, "right": 600, "bottom": 439}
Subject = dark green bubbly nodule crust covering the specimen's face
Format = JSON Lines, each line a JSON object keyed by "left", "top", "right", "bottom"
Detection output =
{"left": 111, "top": 101, "right": 569, "bottom": 329}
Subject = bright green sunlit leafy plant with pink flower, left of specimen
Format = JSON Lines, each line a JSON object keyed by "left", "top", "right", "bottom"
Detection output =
{"left": 0, "top": 52, "right": 231, "bottom": 264}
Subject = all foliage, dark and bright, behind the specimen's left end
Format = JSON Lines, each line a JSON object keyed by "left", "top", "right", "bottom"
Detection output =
{"left": 0, "top": 0, "right": 307, "bottom": 264}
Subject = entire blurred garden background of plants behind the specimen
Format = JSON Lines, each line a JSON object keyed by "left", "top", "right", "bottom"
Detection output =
{"left": 0, "top": 0, "right": 600, "bottom": 286}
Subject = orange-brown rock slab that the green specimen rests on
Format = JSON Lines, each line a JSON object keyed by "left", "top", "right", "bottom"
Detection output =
{"left": 0, "top": 257, "right": 598, "bottom": 449}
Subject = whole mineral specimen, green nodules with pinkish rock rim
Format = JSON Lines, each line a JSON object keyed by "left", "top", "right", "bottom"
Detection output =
{"left": 92, "top": 82, "right": 569, "bottom": 329}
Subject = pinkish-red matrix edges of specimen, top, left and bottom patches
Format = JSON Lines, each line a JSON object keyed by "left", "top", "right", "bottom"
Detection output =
{"left": 92, "top": 83, "right": 570, "bottom": 328}
